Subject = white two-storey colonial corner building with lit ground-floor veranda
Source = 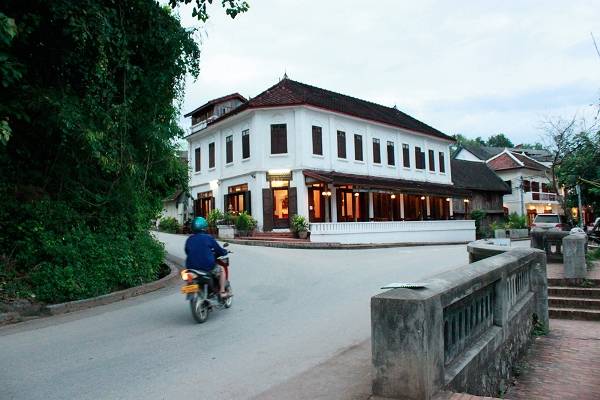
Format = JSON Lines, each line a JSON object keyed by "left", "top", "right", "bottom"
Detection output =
{"left": 186, "top": 78, "right": 474, "bottom": 242}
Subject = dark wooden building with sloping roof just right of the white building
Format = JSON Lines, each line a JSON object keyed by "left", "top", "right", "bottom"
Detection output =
{"left": 451, "top": 159, "right": 511, "bottom": 225}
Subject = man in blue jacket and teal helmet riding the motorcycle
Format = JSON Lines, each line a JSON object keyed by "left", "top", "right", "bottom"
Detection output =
{"left": 185, "top": 217, "right": 228, "bottom": 298}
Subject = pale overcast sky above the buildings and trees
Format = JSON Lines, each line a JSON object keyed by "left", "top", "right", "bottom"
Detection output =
{"left": 171, "top": 0, "right": 600, "bottom": 144}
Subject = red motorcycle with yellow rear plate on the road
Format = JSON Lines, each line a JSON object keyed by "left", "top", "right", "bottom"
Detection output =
{"left": 180, "top": 243, "right": 233, "bottom": 324}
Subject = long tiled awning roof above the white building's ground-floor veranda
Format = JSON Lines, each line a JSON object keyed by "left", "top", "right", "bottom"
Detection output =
{"left": 302, "top": 170, "right": 471, "bottom": 197}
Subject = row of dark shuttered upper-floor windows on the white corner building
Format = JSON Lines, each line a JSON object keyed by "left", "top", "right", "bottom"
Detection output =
{"left": 194, "top": 124, "right": 446, "bottom": 173}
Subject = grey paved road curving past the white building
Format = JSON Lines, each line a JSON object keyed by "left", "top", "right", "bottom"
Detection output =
{"left": 0, "top": 234, "right": 474, "bottom": 400}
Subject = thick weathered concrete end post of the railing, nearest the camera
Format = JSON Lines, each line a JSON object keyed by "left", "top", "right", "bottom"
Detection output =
{"left": 371, "top": 290, "right": 444, "bottom": 400}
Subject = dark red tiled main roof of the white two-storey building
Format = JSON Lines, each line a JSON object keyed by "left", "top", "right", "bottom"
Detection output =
{"left": 209, "top": 78, "right": 454, "bottom": 141}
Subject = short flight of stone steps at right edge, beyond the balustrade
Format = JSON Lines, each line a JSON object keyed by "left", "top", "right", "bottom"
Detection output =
{"left": 548, "top": 278, "right": 600, "bottom": 321}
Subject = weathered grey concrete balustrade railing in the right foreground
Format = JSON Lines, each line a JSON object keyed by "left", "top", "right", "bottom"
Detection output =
{"left": 371, "top": 249, "right": 548, "bottom": 400}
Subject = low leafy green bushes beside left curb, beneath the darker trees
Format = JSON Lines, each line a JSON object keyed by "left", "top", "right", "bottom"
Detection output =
{"left": 0, "top": 200, "right": 164, "bottom": 303}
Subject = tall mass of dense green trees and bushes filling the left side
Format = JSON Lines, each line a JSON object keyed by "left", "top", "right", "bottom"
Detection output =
{"left": 0, "top": 0, "right": 199, "bottom": 302}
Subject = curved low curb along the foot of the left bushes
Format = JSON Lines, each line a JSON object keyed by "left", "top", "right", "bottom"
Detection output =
{"left": 43, "top": 258, "right": 181, "bottom": 315}
